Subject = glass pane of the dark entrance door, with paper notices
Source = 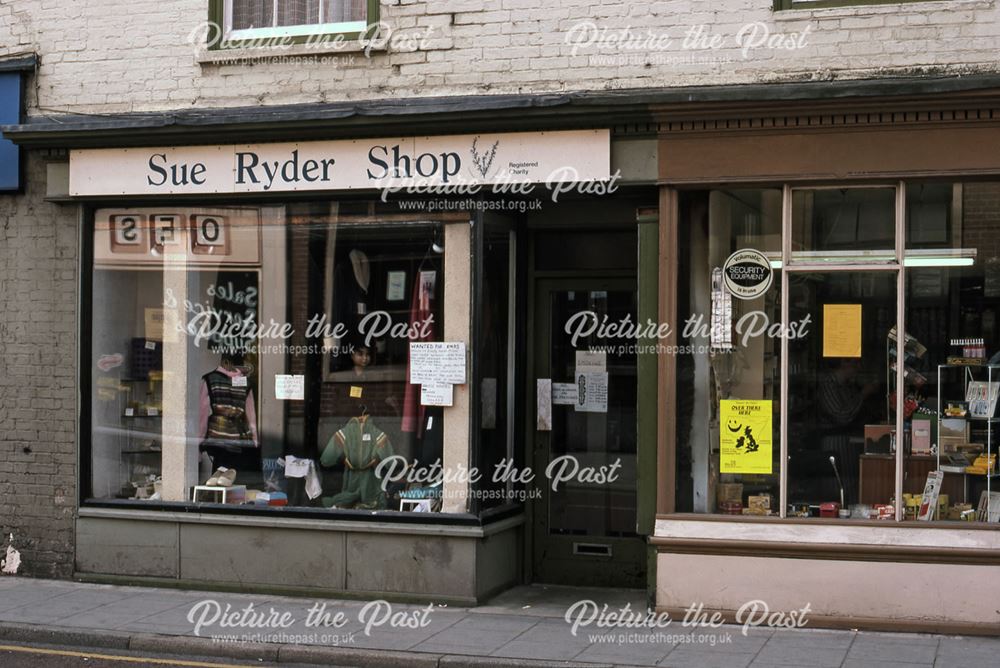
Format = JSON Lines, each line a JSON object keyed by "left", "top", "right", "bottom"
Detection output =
{"left": 548, "top": 290, "right": 637, "bottom": 537}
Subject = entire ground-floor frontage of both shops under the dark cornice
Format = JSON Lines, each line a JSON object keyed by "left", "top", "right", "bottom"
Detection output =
{"left": 5, "top": 78, "right": 1000, "bottom": 620}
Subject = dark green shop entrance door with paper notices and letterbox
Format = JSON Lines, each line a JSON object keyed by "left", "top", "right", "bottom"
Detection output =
{"left": 529, "top": 277, "right": 645, "bottom": 587}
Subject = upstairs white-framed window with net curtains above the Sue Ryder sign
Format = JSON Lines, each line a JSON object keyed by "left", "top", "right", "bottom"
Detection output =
{"left": 222, "top": 0, "right": 378, "bottom": 40}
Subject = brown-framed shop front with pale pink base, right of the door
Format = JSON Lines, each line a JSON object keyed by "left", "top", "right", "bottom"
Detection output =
{"left": 651, "top": 88, "right": 1000, "bottom": 634}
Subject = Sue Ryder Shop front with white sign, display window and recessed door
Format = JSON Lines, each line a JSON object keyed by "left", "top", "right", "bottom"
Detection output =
{"left": 17, "top": 117, "right": 656, "bottom": 603}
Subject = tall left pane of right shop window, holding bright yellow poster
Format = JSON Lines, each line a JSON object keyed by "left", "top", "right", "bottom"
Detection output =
{"left": 676, "top": 189, "right": 781, "bottom": 515}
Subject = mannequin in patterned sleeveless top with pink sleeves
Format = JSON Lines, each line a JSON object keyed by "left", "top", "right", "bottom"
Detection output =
{"left": 198, "top": 352, "right": 260, "bottom": 483}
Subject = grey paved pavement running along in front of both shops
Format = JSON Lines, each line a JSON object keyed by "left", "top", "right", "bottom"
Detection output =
{"left": 0, "top": 577, "right": 1000, "bottom": 668}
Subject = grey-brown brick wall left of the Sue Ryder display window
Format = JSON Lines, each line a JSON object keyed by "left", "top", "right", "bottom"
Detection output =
{"left": 0, "top": 154, "right": 78, "bottom": 577}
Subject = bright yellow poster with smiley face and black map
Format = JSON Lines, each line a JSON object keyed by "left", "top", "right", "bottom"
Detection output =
{"left": 719, "top": 399, "right": 774, "bottom": 473}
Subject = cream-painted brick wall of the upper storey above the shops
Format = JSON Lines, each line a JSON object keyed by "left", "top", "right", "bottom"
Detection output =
{"left": 0, "top": 0, "right": 1000, "bottom": 114}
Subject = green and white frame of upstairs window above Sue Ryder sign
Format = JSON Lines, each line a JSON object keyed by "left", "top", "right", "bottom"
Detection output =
{"left": 208, "top": 0, "right": 380, "bottom": 50}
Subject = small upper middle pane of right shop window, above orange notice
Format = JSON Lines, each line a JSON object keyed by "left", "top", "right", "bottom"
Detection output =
{"left": 792, "top": 188, "right": 896, "bottom": 264}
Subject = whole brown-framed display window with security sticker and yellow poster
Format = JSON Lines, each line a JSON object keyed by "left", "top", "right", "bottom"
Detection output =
{"left": 675, "top": 181, "right": 1000, "bottom": 526}
